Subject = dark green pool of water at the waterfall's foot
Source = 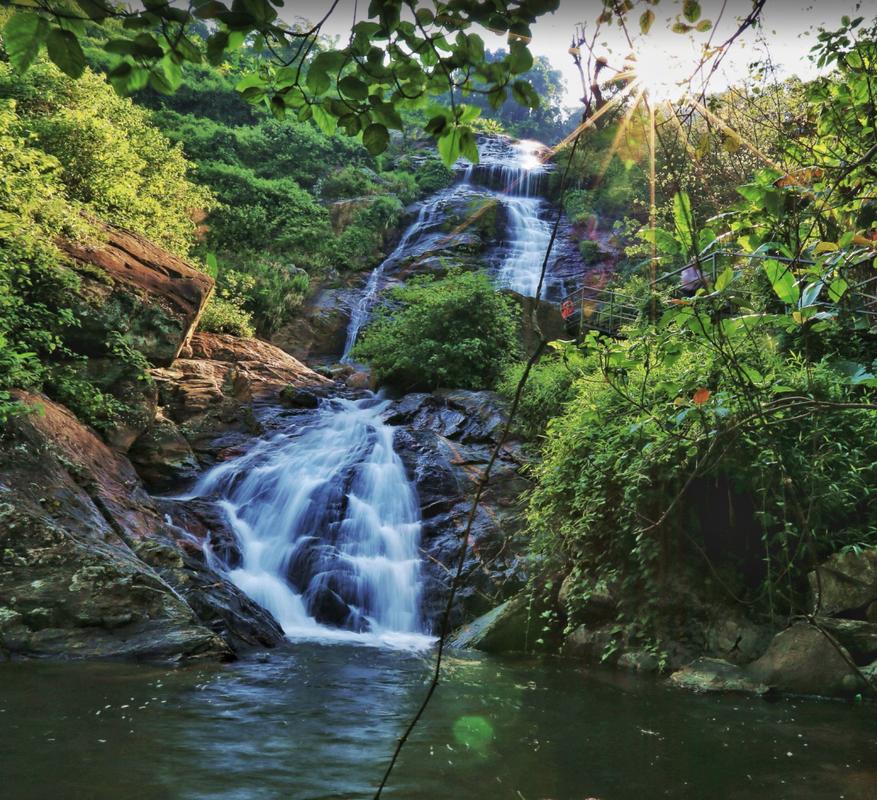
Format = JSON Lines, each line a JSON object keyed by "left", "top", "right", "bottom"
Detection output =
{"left": 0, "top": 643, "right": 877, "bottom": 800}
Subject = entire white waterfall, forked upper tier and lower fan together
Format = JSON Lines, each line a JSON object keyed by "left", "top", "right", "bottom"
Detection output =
{"left": 189, "top": 137, "right": 572, "bottom": 646}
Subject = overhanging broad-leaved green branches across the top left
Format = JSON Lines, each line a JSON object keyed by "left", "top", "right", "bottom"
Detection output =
{"left": 3, "top": 0, "right": 558, "bottom": 165}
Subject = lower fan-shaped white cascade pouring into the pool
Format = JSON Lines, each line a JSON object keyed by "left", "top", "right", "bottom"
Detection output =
{"left": 194, "top": 395, "right": 431, "bottom": 646}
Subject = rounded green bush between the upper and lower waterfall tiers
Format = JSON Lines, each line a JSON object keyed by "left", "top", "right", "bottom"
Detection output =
{"left": 353, "top": 271, "right": 518, "bottom": 390}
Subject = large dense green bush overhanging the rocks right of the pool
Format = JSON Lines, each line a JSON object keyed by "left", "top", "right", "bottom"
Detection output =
{"left": 528, "top": 328, "right": 877, "bottom": 642}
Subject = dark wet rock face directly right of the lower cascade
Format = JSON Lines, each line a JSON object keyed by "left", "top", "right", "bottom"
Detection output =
{"left": 386, "top": 391, "right": 528, "bottom": 626}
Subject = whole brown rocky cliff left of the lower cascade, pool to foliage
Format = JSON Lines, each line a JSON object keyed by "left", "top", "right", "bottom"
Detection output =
{"left": 0, "top": 228, "right": 328, "bottom": 661}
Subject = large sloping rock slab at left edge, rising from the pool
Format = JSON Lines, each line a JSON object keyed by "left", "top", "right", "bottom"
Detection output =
{"left": 0, "top": 392, "right": 282, "bottom": 660}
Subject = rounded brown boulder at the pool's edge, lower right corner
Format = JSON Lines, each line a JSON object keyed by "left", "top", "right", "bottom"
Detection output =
{"left": 746, "top": 622, "right": 862, "bottom": 695}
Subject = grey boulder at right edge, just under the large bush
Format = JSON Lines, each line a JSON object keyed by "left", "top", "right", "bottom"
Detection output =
{"left": 808, "top": 547, "right": 877, "bottom": 616}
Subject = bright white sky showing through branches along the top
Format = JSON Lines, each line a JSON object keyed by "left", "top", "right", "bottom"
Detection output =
{"left": 310, "top": 0, "right": 875, "bottom": 106}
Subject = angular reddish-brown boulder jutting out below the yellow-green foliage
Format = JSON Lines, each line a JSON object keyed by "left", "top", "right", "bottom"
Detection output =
{"left": 60, "top": 226, "right": 213, "bottom": 367}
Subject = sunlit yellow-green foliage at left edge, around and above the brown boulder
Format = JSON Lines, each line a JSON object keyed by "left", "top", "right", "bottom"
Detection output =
{"left": 0, "top": 51, "right": 207, "bottom": 427}
